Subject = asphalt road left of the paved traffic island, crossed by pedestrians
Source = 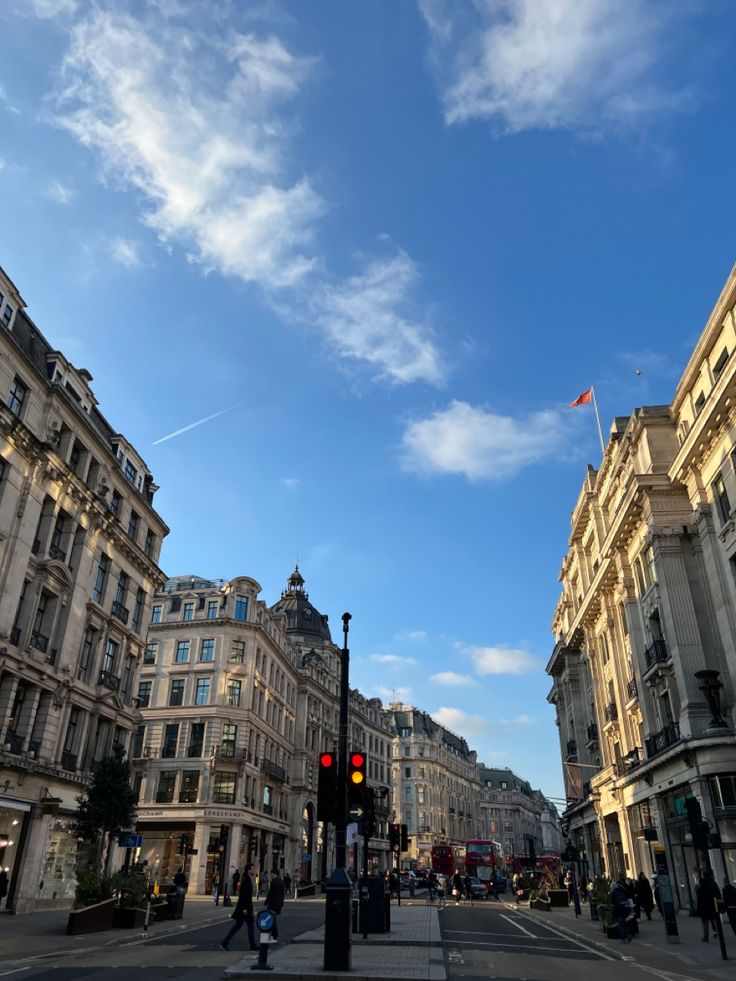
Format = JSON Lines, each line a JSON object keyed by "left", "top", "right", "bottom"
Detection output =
{"left": 0, "top": 902, "right": 324, "bottom": 981}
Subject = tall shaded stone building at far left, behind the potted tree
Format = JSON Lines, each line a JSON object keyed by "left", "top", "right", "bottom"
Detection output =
{"left": 0, "top": 270, "right": 168, "bottom": 912}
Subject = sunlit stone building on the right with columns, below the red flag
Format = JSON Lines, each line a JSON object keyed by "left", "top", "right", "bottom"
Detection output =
{"left": 547, "top": 264, "right": 736, "bottom": 908}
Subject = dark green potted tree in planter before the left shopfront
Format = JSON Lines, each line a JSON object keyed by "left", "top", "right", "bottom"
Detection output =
{"left": 67, "top": 746, "right": 136, "bottom": 934}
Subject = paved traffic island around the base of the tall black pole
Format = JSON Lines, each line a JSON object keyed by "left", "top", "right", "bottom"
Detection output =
{"left": 224, "top": 898, "right": 447, "bottom": 981}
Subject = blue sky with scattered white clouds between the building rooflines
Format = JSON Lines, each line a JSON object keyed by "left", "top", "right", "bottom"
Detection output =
{"left": 0, "top": 0, "right": 735, "bottom": 796}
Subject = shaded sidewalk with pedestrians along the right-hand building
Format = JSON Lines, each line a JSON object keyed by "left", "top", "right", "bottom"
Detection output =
{"left": 503, "top": 899, "right": 736, "bottom": 981}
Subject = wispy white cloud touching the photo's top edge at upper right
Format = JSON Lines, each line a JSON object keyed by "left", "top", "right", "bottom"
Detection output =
{"left": 419, "top": 0, "right": 690, "bottom": 133}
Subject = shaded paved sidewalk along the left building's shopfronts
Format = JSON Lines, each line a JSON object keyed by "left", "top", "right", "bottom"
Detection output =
{"left": 0, "top": 896, "right": 232, "bottom": 961}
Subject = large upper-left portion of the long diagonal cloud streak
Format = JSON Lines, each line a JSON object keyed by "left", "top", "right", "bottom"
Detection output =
{"left": 59, "top": 11, "right": 322, "bottom": 287}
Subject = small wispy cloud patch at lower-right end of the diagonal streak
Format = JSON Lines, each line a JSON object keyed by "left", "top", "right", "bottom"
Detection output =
{"left": 311, "top": 252, "right": 443, "bottom": 384}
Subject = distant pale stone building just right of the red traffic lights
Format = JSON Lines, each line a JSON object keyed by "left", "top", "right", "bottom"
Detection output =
{"left": 389, "top": 702, "right": 483, "bottom": 868}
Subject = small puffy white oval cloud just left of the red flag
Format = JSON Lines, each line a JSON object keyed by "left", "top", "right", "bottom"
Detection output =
{"left": 402, "top": 401, "right": 567, "bottom": 480}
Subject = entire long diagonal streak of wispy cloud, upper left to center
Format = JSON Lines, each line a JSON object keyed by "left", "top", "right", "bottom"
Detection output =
{"left": 51, "top": 4, "right": 444, "bottom": 384}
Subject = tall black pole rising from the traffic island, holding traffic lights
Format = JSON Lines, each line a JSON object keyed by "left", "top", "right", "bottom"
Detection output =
{"left": 324, "top": 613, "right": 353, "bottom": 971}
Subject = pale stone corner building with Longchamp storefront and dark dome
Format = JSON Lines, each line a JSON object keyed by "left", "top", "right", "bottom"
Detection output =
{"left": 131, "top": 569, "right": 391, "bottom": 894}
